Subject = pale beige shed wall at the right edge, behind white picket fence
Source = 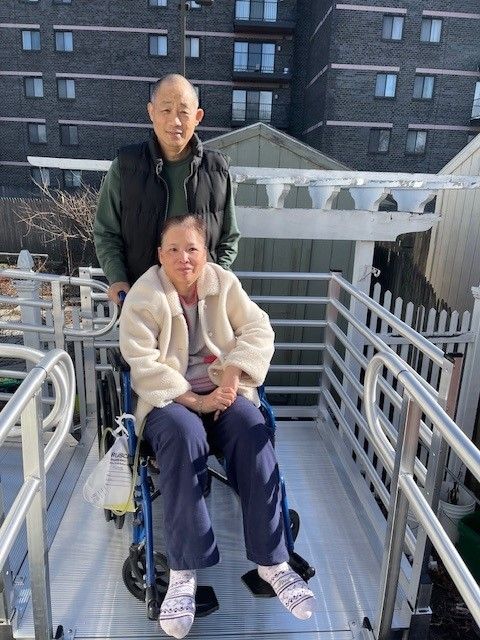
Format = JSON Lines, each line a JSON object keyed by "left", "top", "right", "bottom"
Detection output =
{"left": 425, "top": 135, "right": 480, "bottom": 312}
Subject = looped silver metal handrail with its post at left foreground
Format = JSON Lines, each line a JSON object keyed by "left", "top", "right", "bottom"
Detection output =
{"left": 0, "top": 345, "right": 75, "bottom": 640}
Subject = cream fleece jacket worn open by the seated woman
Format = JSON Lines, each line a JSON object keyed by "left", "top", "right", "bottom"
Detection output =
{"left": 120, "top": 263, "right": 274, "bottom": 428}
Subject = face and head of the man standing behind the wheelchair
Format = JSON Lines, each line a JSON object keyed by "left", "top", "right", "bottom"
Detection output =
{"left": 148, "top": 80, "right": 203, "bottom": 160}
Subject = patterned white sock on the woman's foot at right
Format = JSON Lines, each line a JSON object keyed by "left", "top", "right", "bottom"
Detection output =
{"left": 258, "top": 562, "right": 315, "bottom": 620}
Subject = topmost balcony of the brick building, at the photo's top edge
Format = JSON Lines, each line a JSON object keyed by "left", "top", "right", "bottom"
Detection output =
{"left": 233, "top": 0, "right": 295, "bottom": 33}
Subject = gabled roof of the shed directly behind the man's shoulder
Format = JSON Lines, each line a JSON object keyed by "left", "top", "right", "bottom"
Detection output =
{"left": 205, "top": 122, "right": 350, "bottom": 170}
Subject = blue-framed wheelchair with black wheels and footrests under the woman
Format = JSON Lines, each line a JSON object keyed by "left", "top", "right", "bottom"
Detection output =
{"left": 97, "top": 348, "right": 315, "bottom": 620}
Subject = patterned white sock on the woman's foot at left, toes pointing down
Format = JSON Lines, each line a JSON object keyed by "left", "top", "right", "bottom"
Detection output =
{"left": 158, "top": 569, "right": 197, "bottom": 638}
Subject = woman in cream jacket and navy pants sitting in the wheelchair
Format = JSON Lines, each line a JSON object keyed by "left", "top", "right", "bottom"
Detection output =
{"left": 120, "top": 215, "right": 314, "bottom": 638}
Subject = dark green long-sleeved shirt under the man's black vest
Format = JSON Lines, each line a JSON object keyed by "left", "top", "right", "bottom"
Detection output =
{"left": 94, "top": 156, "right": 240, "bottom": 284}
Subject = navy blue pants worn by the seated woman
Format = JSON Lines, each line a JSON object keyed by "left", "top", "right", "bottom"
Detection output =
{"left": 143, "top": 396, "right": 288, "bottom": 569}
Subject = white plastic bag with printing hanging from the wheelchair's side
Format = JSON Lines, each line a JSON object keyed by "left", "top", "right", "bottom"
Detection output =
{"left": 83, "top": 431, "right": 135, "bottom": 513}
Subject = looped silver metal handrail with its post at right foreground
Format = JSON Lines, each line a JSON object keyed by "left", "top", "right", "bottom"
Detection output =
{"left": 364, "top": 351, "right": 480, "bottom": 640}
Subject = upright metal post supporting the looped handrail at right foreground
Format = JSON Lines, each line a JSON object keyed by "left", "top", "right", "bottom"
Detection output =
{"left": 375, "top": 392, "right": 422, "bottom": 640}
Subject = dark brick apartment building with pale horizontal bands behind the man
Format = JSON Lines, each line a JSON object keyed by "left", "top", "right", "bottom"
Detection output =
{"left": 0, "top": 0, "right": 480, "bottom": 193}
